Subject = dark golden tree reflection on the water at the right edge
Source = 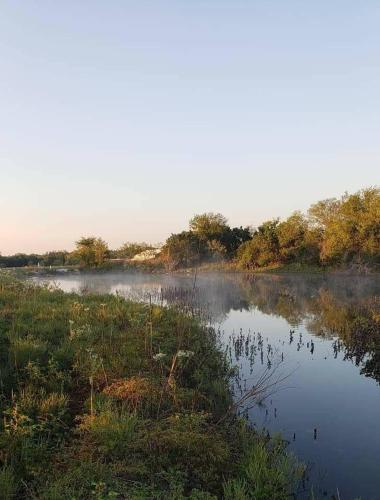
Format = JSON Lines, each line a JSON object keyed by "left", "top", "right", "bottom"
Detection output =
{"left": 241, "top": 276, "right": 380, "bottom": 383}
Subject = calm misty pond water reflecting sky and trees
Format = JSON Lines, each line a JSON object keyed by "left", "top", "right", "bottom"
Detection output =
{"left": 34, "top": 272, "right": 380, "bottom": 500}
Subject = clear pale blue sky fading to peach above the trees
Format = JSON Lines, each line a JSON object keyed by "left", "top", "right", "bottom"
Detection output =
{"left": 0, "top": 0, "right": 380, "bottom": 255}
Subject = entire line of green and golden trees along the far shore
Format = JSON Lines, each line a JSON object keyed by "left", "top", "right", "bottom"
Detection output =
{"left": 0, "top": 187, "right": 380, "bottom": 270}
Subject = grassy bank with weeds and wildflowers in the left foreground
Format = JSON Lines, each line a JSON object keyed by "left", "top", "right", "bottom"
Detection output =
{"left": 0, "top": 275, "right": 303, "bottom": 500}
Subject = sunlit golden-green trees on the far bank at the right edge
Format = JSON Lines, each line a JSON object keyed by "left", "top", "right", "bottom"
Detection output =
{"left": 238, "top": 188, "right": 380, "bottom": 268}
